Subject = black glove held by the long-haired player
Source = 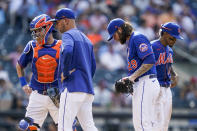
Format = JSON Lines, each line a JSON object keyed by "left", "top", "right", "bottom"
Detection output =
{"left": 115, "top": 79, "right": 133, "bottom": 94}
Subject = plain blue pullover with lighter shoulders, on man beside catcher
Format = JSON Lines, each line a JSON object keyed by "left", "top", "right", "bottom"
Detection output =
{"left": 58, "top": 28, "right": 96, "bottom": 94}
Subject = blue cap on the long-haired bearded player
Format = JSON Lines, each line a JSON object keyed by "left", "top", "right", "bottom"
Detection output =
{"left": 107, "top": 18, "right": 125, "bottom": 41}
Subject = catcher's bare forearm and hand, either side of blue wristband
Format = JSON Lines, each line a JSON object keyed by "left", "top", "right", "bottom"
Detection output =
{"left": 16, "top": 63, "right": 32, "bottom": 95}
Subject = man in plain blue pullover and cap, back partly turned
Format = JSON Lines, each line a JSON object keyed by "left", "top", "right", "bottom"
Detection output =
{"left": 50, "top": 8, "right": 97, "bottom": 131}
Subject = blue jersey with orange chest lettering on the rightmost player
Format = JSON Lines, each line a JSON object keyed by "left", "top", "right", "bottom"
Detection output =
{"left": 151, "top": 40, "right": 173, "bottom": 86}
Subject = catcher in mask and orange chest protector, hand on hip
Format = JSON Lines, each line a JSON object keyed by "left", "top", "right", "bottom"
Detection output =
{"left": 16, "top": 14, "right": 76, "bottom": 131}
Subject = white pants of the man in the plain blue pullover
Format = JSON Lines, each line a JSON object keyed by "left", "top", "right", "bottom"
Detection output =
{"left": 58, "top": 88, "right": 98, "bottom": 131}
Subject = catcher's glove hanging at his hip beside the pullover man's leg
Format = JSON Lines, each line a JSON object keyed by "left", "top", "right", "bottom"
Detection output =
{"left": 47, "top": 87, "right": 60, "bottom": 108}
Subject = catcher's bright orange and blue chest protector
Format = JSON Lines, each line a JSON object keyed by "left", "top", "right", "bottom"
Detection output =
{"left": 32, "top": 41, "right": 61, "bottom": 83}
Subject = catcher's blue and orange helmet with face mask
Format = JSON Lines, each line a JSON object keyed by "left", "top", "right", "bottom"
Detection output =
{"left": 30, "top": 14, "right": 53, "bottom": 46}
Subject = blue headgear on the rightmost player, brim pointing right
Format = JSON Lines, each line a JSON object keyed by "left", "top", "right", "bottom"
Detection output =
{"left": 161, "top": 22, "right": 183, "bottom": 40}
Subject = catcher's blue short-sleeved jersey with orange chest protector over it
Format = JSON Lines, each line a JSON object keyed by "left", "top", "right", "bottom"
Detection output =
{"left": 18, "top": 40, "right": 60, "bottom": 91}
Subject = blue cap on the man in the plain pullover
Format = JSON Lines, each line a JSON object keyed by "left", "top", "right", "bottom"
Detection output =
{"left": 51, "top": 8, "right": 75, "bottom": 21}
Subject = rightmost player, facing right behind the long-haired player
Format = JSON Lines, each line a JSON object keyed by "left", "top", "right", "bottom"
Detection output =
{"left": 151, "top": 22, "right": 183, "bottom": 131}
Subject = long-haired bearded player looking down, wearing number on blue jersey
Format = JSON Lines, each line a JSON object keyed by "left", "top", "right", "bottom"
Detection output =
{"left": 107, "top": 18, "right": 160, "bottom": 131}
